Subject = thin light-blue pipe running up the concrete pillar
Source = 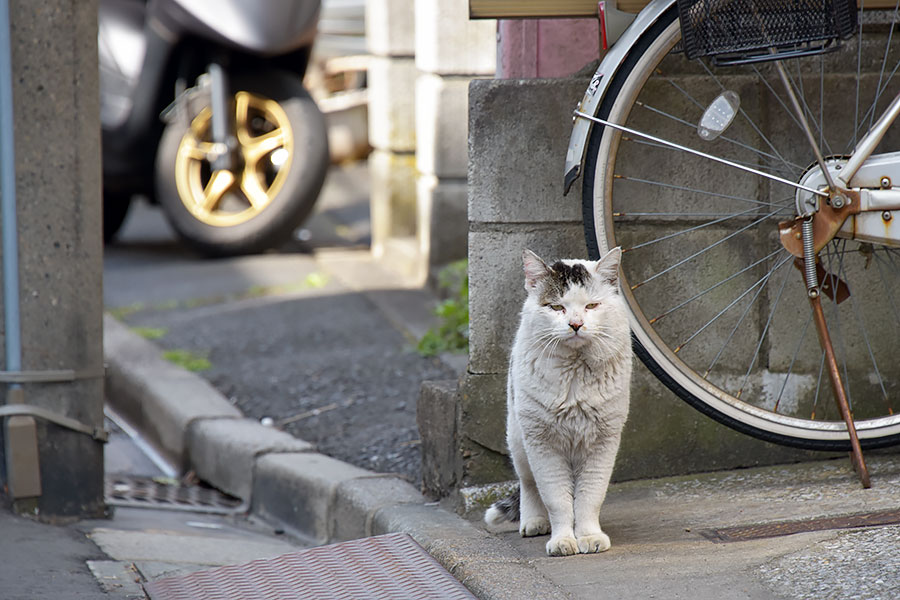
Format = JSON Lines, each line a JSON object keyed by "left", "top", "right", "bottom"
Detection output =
{"left": 0, "top": 0, "right": 22, "bottom": 378}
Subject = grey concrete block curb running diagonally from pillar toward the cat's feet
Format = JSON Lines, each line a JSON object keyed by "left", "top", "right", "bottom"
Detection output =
{"left": 103, "top": 315, "right": 568, "bottom": 600}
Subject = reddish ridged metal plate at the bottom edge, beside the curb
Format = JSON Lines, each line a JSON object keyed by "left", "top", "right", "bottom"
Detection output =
{"left": 144, "top": 533, "right": 475, "bottom": 600}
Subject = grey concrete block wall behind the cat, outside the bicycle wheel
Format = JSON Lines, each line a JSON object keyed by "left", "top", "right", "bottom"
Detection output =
{"left": 420, "top": 77, "right": 836, "bottom": 502}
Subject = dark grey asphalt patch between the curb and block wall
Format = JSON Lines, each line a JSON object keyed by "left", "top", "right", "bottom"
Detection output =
{"left": 126, "top": 260, "right": 456, "bottom": 483}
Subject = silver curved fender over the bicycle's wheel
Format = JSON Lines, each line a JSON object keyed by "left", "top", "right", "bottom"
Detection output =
{"left": 563, "top": 0, "right": 676, "bottom": 195}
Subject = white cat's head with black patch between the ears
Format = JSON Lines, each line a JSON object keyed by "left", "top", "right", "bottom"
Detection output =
{"left": 522, "top": 248, "right": 630, "bottom": 353}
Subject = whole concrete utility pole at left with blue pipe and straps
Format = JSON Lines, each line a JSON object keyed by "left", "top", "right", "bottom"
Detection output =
{"left": 0, "top": 0, "right": 105, "bottom": 520}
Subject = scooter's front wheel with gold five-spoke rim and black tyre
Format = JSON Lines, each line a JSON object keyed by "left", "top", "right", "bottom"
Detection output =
{"left": 156, "top": 71, "right": 328, "bottom": 256}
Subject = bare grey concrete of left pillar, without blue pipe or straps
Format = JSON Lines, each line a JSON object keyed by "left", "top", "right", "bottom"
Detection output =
{"left": 2, "top": 0, "right": 103, "bottom": 518}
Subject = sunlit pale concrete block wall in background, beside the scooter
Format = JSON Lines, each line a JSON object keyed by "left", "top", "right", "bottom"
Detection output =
{"left": 366, "top": 0, "right": 496, "bottom": 282}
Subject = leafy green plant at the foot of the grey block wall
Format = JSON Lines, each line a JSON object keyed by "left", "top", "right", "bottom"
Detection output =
{"left": 416, "top": 260, "right": 469, "bottom": 356}
